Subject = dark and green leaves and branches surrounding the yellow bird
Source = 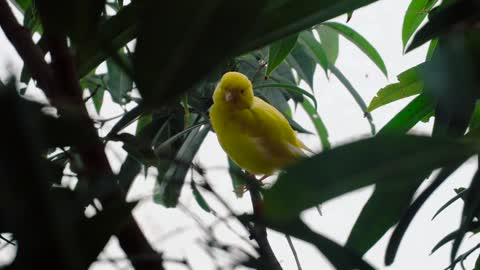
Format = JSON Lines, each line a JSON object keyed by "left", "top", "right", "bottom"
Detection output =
{"left": 0, "top": 0, "right": 480, "bottom": 269}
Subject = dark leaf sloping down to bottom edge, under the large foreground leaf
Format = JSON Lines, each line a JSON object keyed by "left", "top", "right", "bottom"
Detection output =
{"left": 258, "top": 218, "right": 374, "bottom": 270}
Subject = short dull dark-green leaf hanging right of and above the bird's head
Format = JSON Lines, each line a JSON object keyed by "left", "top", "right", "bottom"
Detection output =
{"left": 287, "top": 42, "right": 317, "bottom": 89}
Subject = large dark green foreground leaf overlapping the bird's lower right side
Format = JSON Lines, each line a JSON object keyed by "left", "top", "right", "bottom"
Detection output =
{"left": 264, "top": 135, "right": 475, "bottom": 219}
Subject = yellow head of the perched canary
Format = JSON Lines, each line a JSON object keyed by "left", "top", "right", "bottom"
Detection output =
{"left": 213, "top": 72, "right": 253, "bottom": 109}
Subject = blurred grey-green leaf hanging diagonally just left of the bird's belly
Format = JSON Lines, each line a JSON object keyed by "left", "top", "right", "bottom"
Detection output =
{"left": 157, "top": 125, "right": 210, "bottom": 207}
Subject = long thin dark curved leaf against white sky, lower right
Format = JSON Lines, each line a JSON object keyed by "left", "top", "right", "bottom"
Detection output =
{"left": 385, "top": 163, "right": 465, "bottom": 265}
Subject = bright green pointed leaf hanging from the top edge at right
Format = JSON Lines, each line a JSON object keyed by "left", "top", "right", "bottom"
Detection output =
{"left": 402, "top": 0, "right": 438, "bottom": 49}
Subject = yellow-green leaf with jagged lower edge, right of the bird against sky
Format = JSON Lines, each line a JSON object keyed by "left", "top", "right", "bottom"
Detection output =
{"left": 367, "top": 63, "right": 423, "bottom": 112}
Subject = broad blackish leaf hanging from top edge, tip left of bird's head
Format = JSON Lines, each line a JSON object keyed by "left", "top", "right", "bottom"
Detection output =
{"left": 133, "top": 0, "right": 265, "bottom": 107}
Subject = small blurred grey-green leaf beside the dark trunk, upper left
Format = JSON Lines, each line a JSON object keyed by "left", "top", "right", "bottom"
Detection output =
{"left": 107, "top": 52, "right": 133, "bottom": 104}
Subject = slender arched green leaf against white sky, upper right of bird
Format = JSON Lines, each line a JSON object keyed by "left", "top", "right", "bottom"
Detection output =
{"left": 322, "top": 22, "right": 388, "bottom": 77}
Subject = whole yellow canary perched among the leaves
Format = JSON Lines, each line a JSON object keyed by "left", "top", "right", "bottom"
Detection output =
{"left": 210, "top": 72, "right": 309, "bottom": 175}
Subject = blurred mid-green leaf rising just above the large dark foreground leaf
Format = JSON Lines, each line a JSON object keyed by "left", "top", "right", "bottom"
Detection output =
{"left": 378, "top": 94, "right": 435, "bottom": 134}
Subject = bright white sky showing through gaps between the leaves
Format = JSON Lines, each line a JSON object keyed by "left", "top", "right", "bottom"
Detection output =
{"left": 0, "top": 1, "right": 479, "bottom": 270}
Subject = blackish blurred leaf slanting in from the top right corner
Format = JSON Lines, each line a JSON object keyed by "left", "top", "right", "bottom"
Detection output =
{"left": 406, "top": 1, "right": 480, "bottom": 52}
